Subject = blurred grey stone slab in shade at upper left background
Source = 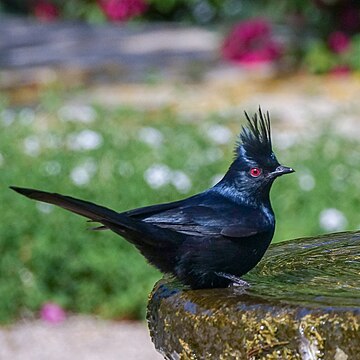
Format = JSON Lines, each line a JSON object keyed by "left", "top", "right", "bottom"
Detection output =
{"left": 0, "top": 16, "right": 219, "bottom": 86}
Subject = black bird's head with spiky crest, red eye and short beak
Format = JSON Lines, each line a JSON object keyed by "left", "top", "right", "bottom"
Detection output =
{"left": 219, "top": 108, "right": 294, "bottom": 201}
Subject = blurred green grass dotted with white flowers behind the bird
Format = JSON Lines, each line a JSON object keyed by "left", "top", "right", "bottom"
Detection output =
{"left": 0, "top": 92, "right": 360, "bottom": 323}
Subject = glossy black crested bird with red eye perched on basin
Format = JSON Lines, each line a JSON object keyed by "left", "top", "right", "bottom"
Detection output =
{"left": 11, "top": 109, "right": 294, "bottom": 289}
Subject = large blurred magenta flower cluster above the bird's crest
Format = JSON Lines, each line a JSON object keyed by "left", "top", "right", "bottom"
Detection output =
{"left": 222, "top": 18, "right": 282, "bottom": 65}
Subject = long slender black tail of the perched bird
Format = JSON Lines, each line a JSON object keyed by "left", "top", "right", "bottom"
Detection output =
{"left": 10, "top": 186, "right": 176, "bottom": 248}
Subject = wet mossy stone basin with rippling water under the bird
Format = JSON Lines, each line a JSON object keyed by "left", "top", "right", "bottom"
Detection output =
{"left": 148, "top": 232, "right": 360, "bottom": 360}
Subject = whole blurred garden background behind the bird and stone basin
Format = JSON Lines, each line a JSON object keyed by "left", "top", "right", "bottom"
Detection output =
{"left": 0, "top": 0, "right": 360, "bottom": 359}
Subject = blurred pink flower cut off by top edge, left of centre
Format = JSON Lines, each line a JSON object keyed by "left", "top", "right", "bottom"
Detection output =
{"left": 98, "top": 0, "right": 148, "bottom": 21}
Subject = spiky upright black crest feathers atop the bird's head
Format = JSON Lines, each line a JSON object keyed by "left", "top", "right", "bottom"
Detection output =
{"left": 235, "top": 107, "right": 272, "bottom": 160}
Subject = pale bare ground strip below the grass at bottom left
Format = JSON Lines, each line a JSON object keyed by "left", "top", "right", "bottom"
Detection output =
{"left": 0, "top": 316, "right": 163, "bottom": 360}
